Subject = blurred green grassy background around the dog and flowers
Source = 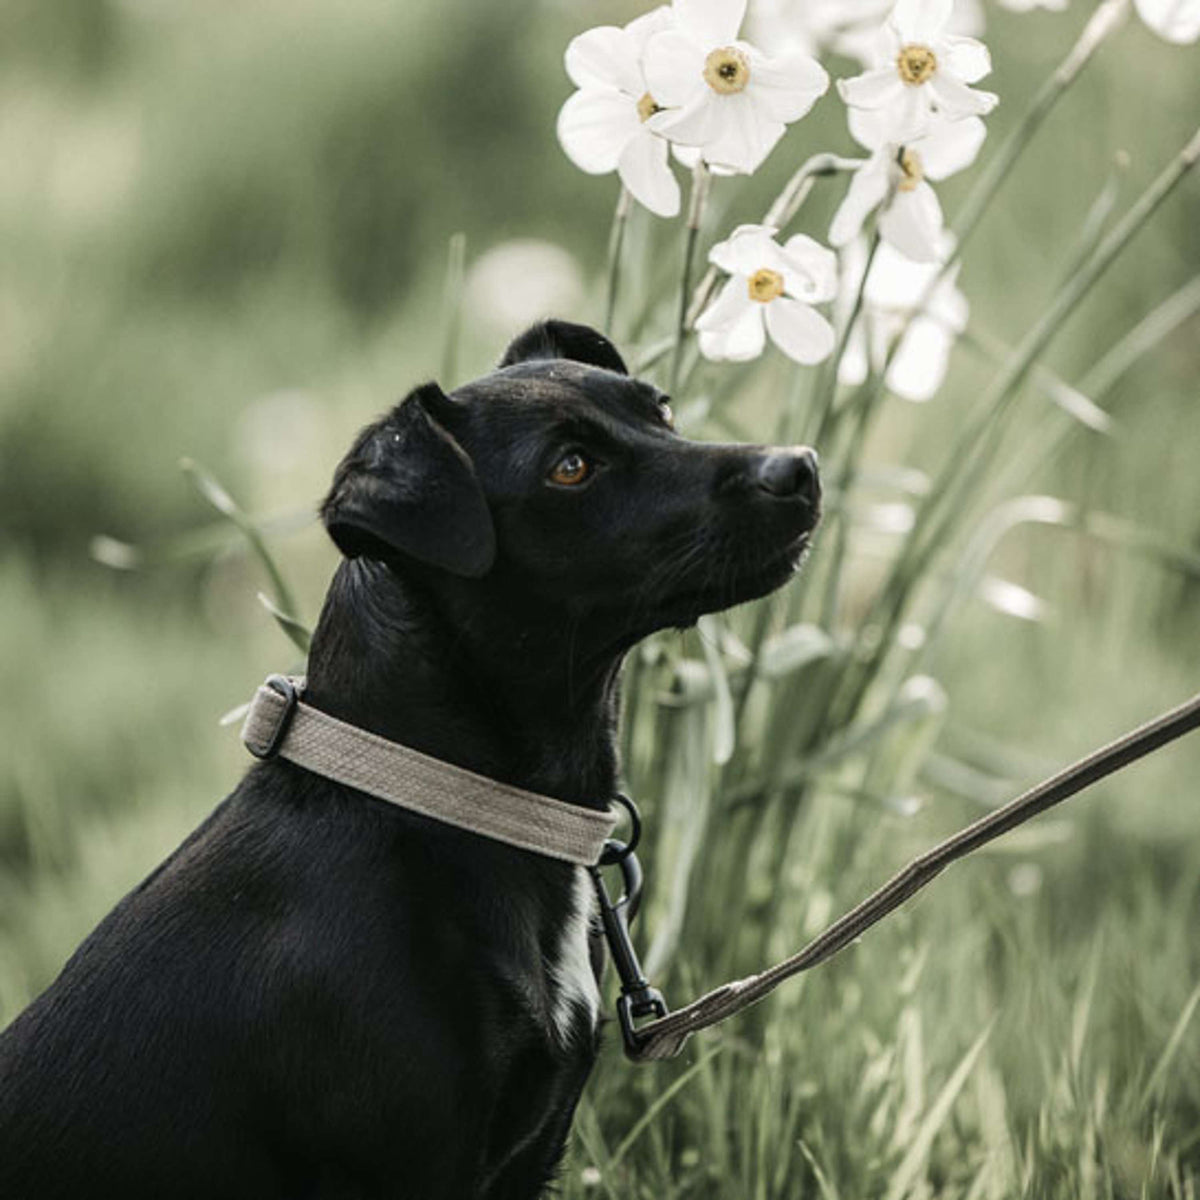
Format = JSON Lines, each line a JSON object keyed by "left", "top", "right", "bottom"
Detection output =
{"left": 0, "top": 0, "right": 1200, "bottom": 1198}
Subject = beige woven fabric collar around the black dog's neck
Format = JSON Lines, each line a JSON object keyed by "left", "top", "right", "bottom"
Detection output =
{"left": 241, "top": 676, "right": 617, "bottom": 866}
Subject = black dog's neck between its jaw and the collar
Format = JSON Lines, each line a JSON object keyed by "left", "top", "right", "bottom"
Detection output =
{"left": 305, "top": 558, "right": 623, "bottom": 808}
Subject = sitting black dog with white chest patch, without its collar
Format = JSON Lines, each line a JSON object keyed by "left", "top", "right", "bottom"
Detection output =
{"left": 0, "top": 323, "right": 818, "bottom": 1200}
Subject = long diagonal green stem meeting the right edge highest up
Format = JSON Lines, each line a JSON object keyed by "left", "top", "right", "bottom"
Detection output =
{"left": 839, "top": 119, "right": 1200, "bottom": 720}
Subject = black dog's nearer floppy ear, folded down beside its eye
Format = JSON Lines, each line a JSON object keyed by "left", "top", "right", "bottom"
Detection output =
{"left": 320, "top": 383, "right": 496, "bottom": 578}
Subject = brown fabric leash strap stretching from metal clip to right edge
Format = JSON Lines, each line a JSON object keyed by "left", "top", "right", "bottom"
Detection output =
{"left": 626, "top": 695, "right": 1200, "bottom": 1061}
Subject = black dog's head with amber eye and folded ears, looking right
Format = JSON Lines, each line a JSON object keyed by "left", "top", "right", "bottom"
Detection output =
{"left": 322, "top": 322, "right": 820, "bottom": 667}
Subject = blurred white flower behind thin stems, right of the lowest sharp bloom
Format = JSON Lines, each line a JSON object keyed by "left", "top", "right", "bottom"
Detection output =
{"left": 838, "top": 233, "right": 970, "bottom": 401}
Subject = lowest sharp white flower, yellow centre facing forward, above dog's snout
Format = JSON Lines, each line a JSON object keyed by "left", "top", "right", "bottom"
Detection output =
{"left": 696, "top": 226, "right": 838, "bottom": 364}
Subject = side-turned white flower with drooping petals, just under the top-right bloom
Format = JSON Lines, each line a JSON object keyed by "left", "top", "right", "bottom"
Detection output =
{"left": 829, "top": 108, "right": 988, "bottom": 263}
